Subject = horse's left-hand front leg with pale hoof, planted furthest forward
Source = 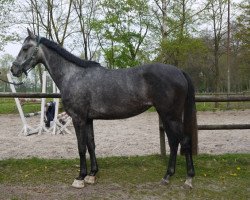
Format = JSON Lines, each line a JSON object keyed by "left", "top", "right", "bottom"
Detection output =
{"left": 72, "top": 118, "right": 88, "bottom": 188}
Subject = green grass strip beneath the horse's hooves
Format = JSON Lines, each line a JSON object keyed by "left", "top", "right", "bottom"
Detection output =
{"left": 0, "top": 154, "right": 250, "bottom": 199}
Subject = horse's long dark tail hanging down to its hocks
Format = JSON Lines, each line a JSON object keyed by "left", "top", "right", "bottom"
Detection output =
{"left": 181, "top": 72, "right": 198, "bottom": 155}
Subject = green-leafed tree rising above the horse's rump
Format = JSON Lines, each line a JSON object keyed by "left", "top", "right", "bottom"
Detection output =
{"left": 155, "top": 0, "right": 207, "bottom": 69}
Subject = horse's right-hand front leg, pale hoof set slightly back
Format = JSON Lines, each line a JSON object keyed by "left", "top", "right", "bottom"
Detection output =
{"left": 84, "top": 119, "right": 98, "bottom": 184}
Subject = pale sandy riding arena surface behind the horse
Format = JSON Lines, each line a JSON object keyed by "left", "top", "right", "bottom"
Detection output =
{"left": 0, "top": 110, "right": 250, "bottom": 159}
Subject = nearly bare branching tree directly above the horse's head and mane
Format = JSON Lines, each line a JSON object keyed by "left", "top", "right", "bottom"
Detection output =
{"left": 23, "top": 0, "right": 73, "bottom": 46}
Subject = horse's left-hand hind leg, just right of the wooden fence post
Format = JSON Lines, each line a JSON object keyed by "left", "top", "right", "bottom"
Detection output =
{"left": 162, "top": 118, "right": 182, "bottom": 184}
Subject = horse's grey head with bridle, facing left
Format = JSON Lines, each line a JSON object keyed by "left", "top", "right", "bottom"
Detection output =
{"left": 11, "top": 29, "right": 40, "bottom": 77}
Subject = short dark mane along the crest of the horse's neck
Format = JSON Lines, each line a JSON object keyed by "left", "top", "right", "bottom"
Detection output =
{"left": 40, "top": 37, "right": 101, "bottom": 68}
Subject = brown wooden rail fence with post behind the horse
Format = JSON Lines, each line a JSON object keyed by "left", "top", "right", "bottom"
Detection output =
{"left": 0, "top": 93, "right": 250, "bottom": 156}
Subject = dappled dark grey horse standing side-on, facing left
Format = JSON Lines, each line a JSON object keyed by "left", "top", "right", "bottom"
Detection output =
{"left": 11, "top": 30, "right": 197, "bottom": 188}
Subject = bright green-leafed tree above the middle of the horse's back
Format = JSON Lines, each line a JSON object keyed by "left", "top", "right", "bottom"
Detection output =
{"left": 94, "top": 0, "right": 149, "bottom": 68}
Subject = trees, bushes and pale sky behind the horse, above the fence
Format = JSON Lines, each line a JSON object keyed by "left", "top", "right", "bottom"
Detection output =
{"left": 0, "top": 0, "right": 250, "bottom": 92}
